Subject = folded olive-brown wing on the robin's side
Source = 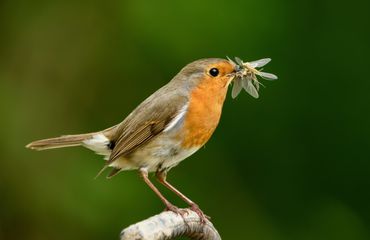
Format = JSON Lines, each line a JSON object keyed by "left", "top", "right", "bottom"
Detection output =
{"left": 107, "top": 90, "right": 187, "bottom": 165}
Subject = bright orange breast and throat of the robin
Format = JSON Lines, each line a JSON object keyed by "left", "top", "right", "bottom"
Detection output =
{"left": 182, "top": 78, "right": 227, "bottom": 148}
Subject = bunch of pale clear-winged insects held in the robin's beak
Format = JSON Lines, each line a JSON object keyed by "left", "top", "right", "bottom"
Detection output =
{"left": 228, "top": 57, "right": 278, "bottom": 98}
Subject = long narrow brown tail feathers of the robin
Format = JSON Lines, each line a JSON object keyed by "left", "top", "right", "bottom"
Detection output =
{"left": 26, "top": 133, "right": 96, "bottom": 150}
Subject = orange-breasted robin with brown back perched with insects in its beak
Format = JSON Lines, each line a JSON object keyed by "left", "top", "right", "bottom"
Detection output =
{"left": 27, "top": 58, "right": 278, "bottom": 220}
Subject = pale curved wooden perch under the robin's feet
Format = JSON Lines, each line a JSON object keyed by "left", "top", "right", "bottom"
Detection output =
{"left": 121, "top": 209, "right": 221, "bottom": 240}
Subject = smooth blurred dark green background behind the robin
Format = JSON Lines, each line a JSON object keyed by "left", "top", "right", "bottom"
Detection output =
{"left": 0, "top": 0, "right": 370, "bottom": 240}
